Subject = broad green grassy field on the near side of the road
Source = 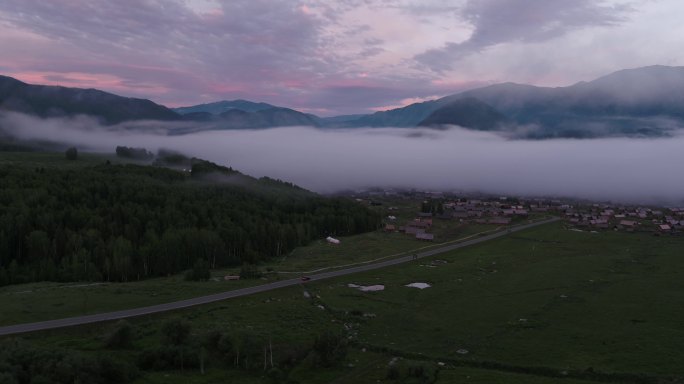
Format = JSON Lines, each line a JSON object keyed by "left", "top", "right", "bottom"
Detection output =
{"left": 9, "top": 223, "right": 684, "bottom": 384}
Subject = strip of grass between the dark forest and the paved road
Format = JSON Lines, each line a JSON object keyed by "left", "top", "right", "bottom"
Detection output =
{"left": 0, "top": 222, "right": 502, "bottom": 326}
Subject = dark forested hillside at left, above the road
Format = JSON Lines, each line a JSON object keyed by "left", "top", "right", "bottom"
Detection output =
{"left": 0, "top": 162, "right": 379, "bottom": 285}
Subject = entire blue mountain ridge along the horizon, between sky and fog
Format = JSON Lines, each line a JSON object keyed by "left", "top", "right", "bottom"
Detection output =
{"left": 0, "top": 65, "right": 684, "bottom": 138}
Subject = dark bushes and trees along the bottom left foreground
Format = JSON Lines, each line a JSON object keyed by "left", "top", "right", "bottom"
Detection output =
{"left": 0, "top": 318, "right": 347, "bottom": 384}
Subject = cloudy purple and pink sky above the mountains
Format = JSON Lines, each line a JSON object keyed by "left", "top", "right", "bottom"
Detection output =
{"left": 0, "top": 0, "right": 684, "bottom": 116}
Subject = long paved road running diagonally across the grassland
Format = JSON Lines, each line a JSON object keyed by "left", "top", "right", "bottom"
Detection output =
{"left": 0, "top": 218, "right": 559, "bottom": 336}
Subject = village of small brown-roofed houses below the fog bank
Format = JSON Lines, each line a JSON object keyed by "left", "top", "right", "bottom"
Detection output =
{"left": 356, "top": 190, "right": 684, "bottom": 241}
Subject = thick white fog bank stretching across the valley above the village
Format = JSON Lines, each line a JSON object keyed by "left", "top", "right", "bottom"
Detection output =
{"left": 0, "top": 114, "right": 684, "bottom": 204}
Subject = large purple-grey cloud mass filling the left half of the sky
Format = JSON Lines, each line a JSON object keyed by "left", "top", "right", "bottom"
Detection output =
{"left": 0, "top": 0, "right": 336, "bottom": 102}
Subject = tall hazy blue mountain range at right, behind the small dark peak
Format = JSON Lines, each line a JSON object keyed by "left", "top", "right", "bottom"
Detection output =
{"left": 346, "top": 66, "right": 684, "bottom": 138}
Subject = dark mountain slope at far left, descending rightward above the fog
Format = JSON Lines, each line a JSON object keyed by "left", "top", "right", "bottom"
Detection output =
{"left": 0, "top": 76, "right": 181, "bottom": 124}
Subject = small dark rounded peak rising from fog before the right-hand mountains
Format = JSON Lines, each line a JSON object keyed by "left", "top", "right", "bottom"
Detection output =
{"left": 418, "top": 97, "right": 507, "bottom": 131}
